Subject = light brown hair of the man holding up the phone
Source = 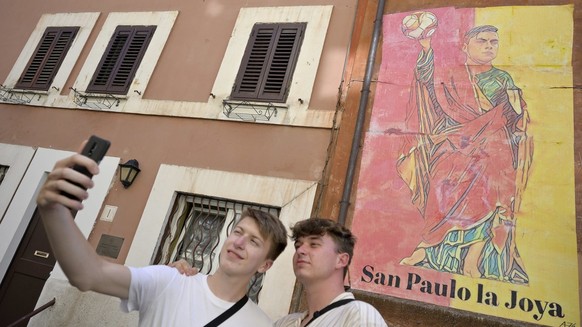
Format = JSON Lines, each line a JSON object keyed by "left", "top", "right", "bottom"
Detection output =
{"left": 237, "top": 207, "right": 287, "bottom": 260}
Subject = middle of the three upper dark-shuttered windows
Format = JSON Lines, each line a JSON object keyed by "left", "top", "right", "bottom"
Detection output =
{"left": 87, "top": 26, "right": 156, "bottom": 94}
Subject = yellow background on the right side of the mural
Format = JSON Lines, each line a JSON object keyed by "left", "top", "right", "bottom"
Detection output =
{"left": 451, "top": 5, "right": 580, "bottom": 326}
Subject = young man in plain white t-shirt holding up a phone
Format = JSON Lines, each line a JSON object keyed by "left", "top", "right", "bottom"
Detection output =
{"left": 37, "top": 149, "right": 287, "bottom": 327}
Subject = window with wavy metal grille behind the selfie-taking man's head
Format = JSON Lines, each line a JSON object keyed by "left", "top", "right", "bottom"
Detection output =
{"left": 154, "top": 194, "right": 280, "bottom": 303}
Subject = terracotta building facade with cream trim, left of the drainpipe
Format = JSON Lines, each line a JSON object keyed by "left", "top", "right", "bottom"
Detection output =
{"left": 0, "top": 1, "right": 356, "bottom": 326}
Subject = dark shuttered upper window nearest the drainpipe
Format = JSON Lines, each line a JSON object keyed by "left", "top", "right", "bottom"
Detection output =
{"left": 231, "top": 23, "right": 306, "bottom": 102}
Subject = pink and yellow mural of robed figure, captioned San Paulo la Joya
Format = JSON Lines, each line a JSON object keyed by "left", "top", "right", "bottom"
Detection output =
{"left": 351, "top": 6, "right": 580, "bottom": 326}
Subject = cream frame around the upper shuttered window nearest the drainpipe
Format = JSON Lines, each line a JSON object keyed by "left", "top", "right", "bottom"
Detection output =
{"left": 213, "top": 5, "right": 341, "bottom": 128}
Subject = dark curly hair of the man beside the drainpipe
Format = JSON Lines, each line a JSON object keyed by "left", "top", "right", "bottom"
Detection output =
{"left": 291, "top": 218, "right": 356, "bottom": 271}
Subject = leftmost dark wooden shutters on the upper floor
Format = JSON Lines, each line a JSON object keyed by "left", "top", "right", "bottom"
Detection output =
{"left": 15, "top": 27, "right": 79, "bottom": 91}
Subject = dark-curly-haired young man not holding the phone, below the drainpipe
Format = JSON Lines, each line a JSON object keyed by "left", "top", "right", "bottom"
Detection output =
{"left": 274, "top": 218, "right": 387, "bottom": 327}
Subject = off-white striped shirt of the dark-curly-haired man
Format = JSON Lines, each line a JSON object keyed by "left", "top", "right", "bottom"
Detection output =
{"left": 274, "top": 292, "right": 387, "bottom": 327}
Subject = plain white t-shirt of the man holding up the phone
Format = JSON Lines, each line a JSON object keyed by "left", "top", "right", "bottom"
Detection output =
{"left": 121, "top": 266, "right": 273, "bottom": 327}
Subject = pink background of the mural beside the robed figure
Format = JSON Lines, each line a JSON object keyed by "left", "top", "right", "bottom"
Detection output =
{"left": 351, "top": 7, "right": 474, "bottom": 306}
